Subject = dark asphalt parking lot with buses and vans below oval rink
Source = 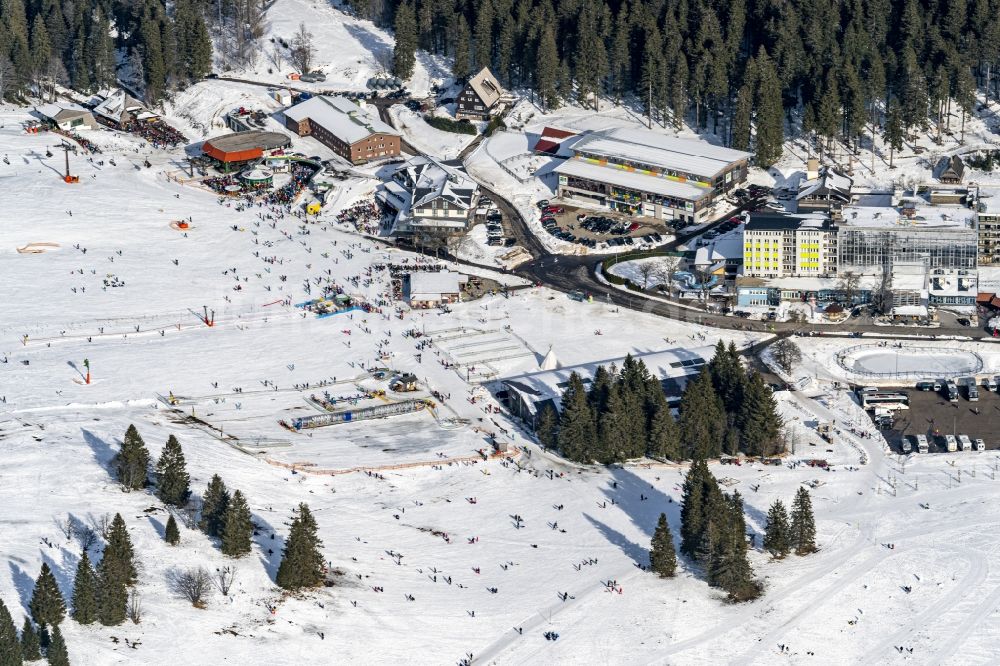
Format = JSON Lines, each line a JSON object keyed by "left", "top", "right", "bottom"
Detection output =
{"left": 882, "top": 386, "right": 1000, "bottom": 455}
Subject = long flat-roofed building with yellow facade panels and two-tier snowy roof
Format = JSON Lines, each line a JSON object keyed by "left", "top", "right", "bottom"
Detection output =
{"left": 554, "top": 127, "right": 750, "bottom": 223}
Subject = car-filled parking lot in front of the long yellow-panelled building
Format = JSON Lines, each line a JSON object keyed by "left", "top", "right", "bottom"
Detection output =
{"left": 542, "top": 201, "right": 671, "bottom": 248}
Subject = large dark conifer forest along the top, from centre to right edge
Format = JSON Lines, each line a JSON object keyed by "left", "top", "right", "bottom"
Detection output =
{"left": 350, "top": 0, "right": 1000, "bottom": 165}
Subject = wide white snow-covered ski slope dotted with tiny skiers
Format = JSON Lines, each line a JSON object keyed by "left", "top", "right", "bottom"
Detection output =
{"left": 0, "top": 106, "right": 1000, "bottom": 666}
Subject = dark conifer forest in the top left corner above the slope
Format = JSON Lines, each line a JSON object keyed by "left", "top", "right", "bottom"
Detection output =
{"left": 0, "top": 0, "right": 213, "bottom": 103}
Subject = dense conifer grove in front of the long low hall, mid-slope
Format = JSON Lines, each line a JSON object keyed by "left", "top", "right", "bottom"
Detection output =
{"left": 537, "top": 340, "right": 784, "bottom": 464}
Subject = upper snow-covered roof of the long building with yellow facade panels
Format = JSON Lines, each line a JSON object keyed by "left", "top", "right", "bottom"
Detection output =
{"left": 563, "top": 127, "right": 750, "bottom": 178}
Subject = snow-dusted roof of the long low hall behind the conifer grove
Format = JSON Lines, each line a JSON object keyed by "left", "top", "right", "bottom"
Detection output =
{"left": 503, "top": 347, "right": 715, "bottom": 409}
